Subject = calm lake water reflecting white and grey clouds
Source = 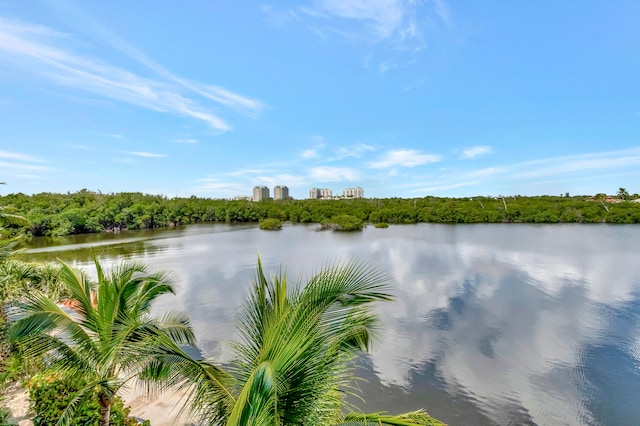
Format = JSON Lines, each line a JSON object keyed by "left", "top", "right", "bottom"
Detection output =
{"left": 21, "top": 224, "right": 640, "bottom": 425}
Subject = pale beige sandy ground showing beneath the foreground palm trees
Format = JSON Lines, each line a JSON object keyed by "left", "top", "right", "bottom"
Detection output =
{"left": 2, "top": 383, "right": 194, "bottom": 426}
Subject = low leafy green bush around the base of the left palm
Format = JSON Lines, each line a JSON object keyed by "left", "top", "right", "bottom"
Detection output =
{"left": 27, "top": 371, "right": 149, "bottom": 426}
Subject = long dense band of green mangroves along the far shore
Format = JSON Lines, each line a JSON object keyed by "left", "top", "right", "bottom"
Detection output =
{"left": 0, "top": 188, "right": 640, "bottom": 236}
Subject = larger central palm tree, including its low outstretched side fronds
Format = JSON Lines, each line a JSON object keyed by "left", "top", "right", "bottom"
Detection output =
{"left": 153, "top": 260, "right": 442, "bottom": 426}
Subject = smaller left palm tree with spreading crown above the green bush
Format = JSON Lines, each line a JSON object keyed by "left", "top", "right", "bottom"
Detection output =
{"left": 9, "top": 260, "right": 195, "bottom": 426}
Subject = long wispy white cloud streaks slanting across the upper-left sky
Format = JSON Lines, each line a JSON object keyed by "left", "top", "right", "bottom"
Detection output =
{"left": 0, "top": 19, "right": 264, "bottom": 131}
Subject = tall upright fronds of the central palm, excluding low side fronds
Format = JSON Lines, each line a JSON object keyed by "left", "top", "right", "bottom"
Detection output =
{"left": 204, "top": 260, "right": 391, "bottom": 424}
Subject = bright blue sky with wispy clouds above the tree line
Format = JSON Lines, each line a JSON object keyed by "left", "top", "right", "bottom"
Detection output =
{"left": 0, "top": 0, "right": 640, "bottom": 198}
